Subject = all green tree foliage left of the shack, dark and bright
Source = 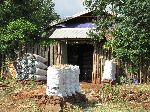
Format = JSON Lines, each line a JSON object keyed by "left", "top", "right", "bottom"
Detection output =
{"left": 0, "top": 0, "right": 59, "bottom": 54}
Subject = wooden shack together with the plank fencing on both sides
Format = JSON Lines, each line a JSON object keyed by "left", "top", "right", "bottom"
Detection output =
{"left": 14, "top": 11, "right": 150, "bottom": 83}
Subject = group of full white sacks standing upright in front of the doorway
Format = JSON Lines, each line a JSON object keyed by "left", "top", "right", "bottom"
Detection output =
{"left": 46, "top": 65, "right": 81, "bottom": 97}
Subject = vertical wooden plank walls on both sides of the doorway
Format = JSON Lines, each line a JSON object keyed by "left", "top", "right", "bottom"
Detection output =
{"left": 1, "top": 43, "right": 150, "bottom": 83}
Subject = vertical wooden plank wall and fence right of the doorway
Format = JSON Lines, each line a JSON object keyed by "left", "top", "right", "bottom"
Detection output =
{"left": 92, "top": 44, "right": 150, "bottom": 83}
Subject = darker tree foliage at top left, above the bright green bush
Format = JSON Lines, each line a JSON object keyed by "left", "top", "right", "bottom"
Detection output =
{"left": 0, "top": 0, "right": 58, "bottom": 30}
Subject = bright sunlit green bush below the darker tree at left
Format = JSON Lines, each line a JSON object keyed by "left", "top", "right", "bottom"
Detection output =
{"left": 0, "top": 19, "right": 37, "bottom": 53}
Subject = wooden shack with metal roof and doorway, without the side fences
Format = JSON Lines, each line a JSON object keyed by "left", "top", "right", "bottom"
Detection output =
{"left": 49, "top": 11, "right": 111, "bottom": 83}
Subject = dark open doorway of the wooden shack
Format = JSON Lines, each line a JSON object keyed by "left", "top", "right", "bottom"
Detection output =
{"left": 67, "top": 44, "right": 94, "bottom": 82}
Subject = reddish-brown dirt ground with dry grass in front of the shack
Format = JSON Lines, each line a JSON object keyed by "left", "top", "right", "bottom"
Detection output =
{"left": 0, "top": 81, "right": 150, "bottom": 112}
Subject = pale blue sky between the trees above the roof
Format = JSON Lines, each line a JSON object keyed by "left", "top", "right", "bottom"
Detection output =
{"left": 53, "top": 0, "right": 85, "bottom": 18}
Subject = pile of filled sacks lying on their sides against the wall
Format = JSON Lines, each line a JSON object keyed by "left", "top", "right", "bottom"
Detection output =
{"left": 16, "top": 53, "right": 47, "bottom": 80}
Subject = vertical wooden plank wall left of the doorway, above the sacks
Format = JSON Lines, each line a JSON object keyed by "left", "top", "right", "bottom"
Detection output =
{"left": 24, "top": 43, "right": 62, "bottom": 66}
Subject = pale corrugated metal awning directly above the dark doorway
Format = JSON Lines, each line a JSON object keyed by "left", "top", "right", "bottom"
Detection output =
{"left": 49, "top": 28, "right": 91, "bottom": 39}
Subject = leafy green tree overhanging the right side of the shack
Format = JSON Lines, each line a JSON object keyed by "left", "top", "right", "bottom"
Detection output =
{"left": 84, "top": 0, "right": 150, "bottom": 73}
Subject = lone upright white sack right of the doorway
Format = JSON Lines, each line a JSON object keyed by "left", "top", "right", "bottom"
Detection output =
{"left": 102, "top": 60, "right": 116, "bottom": 81}
